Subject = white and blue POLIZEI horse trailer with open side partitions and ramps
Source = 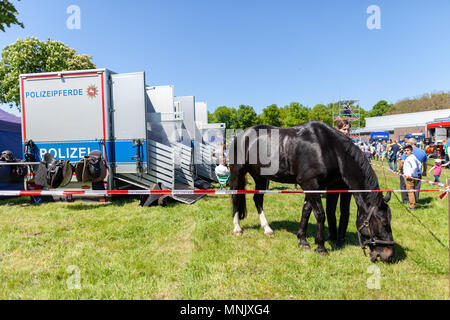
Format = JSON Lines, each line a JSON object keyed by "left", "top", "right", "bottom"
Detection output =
{"left": 20, "top": 69, "right": 201, "bottom": 203}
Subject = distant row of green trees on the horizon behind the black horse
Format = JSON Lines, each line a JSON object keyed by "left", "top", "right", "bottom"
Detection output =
{"left": 208, "top": 100, "right": 392, "bottom": 129}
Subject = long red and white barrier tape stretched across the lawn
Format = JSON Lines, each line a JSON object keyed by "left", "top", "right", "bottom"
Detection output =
{"left": 0, "top": 189, "right": 449, "bottom": 197}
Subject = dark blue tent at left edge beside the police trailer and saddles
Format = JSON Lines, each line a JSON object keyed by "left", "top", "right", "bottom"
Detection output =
{"left": 0, "top": 109, "right": 24, "bottom": 194}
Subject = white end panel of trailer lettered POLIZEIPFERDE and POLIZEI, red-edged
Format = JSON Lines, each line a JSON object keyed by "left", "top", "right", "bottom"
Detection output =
{"left": 20, "top": 70, "right": 107, "bottom": 162}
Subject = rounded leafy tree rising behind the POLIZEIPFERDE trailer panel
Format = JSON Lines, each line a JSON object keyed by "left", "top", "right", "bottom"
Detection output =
{"left": 0, "top": 37, "right": 95, "bottom": 111}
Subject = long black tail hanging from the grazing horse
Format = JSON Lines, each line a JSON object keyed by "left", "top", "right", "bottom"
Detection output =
{"left": 228, "top": 131, "right": 247, "bottom": 220}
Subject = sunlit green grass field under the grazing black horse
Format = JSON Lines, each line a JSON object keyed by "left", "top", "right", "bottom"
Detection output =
{"left": 0, "top": 164, "right": 450, "bottom": 299}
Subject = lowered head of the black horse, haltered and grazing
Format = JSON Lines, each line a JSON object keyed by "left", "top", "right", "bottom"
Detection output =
{"left": 356, "top": 192, "right": 394, "bottom": 262}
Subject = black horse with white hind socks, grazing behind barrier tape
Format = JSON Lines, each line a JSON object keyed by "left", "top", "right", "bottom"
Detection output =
{"left": 230, "top": 121, "right": 394, "bottom": 261}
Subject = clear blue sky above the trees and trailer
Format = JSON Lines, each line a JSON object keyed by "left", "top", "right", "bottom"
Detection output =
{"left": 0, "top": 0, "right": 450, "bottom": 113}
